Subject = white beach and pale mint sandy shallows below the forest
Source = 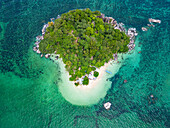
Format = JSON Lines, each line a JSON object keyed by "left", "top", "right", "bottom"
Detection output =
{"left": 51, "top": 53, "right": 128, "bottom": 105}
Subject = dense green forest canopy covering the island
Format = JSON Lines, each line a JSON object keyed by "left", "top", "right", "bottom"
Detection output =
{"left": 39, "top": 9, "right": 130, "bottom": 85}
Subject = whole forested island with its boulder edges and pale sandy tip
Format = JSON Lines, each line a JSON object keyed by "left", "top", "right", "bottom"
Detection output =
{"left": 33, "top": 9, "right": 138, "bottom": 105}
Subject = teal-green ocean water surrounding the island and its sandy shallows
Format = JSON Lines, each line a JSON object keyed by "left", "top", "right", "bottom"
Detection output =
{"left": 0, "top": 0, "right": 170, "bottom": 128}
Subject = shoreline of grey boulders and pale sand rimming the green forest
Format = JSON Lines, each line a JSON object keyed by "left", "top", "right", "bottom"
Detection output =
{"left": 33, "top": 10, "right": 138, "bottom": 106}
